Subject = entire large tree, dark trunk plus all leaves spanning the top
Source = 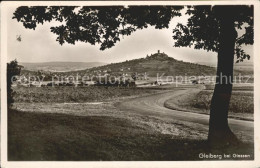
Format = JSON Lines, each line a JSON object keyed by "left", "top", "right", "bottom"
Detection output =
{"left": 13, "top": 5, "right": 253, "bottom": 145}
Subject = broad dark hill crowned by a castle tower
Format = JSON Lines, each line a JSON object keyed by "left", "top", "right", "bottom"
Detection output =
{"left": 74, "top": 52, "right": 216, "bottom": 77}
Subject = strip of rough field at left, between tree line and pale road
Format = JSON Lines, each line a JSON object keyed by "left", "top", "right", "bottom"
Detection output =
{"left": 14, "top": 86, "right": 160, "bottom": 103}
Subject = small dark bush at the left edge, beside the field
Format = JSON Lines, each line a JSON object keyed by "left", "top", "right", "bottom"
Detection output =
{"left": 7, "top": 60, "right": 22, "bottom": 107}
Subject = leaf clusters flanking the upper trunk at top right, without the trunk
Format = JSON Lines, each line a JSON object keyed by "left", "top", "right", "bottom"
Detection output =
{"left": 173, "top": 5, "right": 254, "bottom": 62}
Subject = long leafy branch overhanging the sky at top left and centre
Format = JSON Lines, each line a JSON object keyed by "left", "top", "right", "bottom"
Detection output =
{"left": 13, "top": 6, "right": 183, "bottom": 50}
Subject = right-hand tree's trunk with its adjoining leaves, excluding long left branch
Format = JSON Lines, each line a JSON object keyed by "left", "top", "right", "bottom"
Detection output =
{"left": 173, "top": 6, "right": 253, "bottom": 145}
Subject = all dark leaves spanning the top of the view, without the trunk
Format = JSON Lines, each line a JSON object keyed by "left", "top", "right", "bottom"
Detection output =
{"left": 13, "top": 5, "right": 254, "bottom": 61}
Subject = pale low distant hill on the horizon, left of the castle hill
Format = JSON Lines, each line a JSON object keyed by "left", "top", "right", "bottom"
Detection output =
{"left": 20, "top": 62, "right": 105, "bottom": 72}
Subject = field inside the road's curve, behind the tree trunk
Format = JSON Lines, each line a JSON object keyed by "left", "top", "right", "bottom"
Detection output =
{"left": 165, "top": 89, "right": 254, "bottom": 120}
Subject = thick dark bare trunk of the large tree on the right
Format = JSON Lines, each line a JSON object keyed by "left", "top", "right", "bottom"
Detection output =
{"left": 208, "top": 7, "right": 238, "bottom": 146}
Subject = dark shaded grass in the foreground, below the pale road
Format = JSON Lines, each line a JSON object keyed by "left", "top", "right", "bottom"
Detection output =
{"left": 8, "top": 110, "right": 254, "bottom": 161}
